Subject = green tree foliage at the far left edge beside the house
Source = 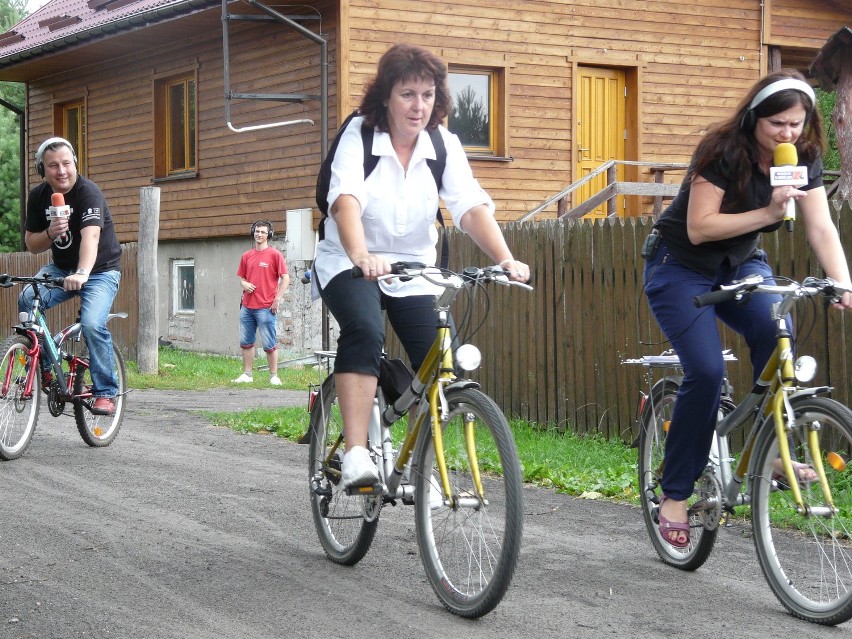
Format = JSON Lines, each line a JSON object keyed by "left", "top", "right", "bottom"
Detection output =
{"left": 0, "top": 0, "right": 27, "bottom": 253}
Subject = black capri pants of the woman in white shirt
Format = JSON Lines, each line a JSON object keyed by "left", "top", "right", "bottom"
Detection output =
{"left": 317, "top": 271, "right": 438, "bottom": 377}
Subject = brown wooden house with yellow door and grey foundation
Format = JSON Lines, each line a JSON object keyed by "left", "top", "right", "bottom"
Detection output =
{"left": 0, "top": 0, "right": 852, "bottom": 352}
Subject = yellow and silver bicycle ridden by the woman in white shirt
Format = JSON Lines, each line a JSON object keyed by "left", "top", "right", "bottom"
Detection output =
{"left": 309, "top": 263, "right": 531, "bottom": 617}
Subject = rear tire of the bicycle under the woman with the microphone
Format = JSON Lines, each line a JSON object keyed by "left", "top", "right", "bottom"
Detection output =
{"left": 638, "top": 378, "right": 717, "bottom": 570}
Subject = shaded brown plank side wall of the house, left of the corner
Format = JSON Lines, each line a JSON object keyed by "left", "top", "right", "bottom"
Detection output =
{"left": 27, "top": 1, "right": 336, "bottom": 246}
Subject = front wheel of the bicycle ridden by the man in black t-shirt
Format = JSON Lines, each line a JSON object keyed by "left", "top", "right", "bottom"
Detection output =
{"left": 0, "top": 335, "right": 41, "bottom": 461}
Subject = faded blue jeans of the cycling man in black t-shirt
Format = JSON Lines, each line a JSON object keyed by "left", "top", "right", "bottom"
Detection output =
{"left": 18, "top": 263, "right": 121, "bottom": 397}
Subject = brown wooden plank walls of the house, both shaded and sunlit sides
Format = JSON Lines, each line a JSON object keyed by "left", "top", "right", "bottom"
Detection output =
{"left": 21, "top": 0, "right": 852, "bottom": 241}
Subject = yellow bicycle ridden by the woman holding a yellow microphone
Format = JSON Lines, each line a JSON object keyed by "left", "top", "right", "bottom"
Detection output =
{"left": 625, "top": 275, "right": 852, "bottom": 625}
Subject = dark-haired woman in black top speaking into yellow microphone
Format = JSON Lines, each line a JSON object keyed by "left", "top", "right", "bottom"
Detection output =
{"left": 645, "top": 69, "right": 852, "bottom": 548}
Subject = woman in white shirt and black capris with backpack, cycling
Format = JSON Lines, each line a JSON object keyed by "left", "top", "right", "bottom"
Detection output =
{"left": 313, "top": 44, "right": 529, "bottom": 487}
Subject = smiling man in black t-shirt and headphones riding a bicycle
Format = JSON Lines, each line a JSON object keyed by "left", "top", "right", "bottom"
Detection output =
{"left": 23, "top": 138, "right": 121, "bottom": 415}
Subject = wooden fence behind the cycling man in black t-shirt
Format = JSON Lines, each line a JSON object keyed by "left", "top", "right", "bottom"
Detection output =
{"left": 0, "top": 243, "right": 139, "bottom": 361}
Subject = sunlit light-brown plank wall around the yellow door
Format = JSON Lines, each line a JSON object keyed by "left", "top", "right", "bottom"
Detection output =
{"left": 340, "top": 0, "right": 837, "bottom": 221}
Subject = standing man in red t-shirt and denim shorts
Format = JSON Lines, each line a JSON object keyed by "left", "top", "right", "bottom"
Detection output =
{"left": 233, "top": 220, "right": 290, "bottom": 386}
